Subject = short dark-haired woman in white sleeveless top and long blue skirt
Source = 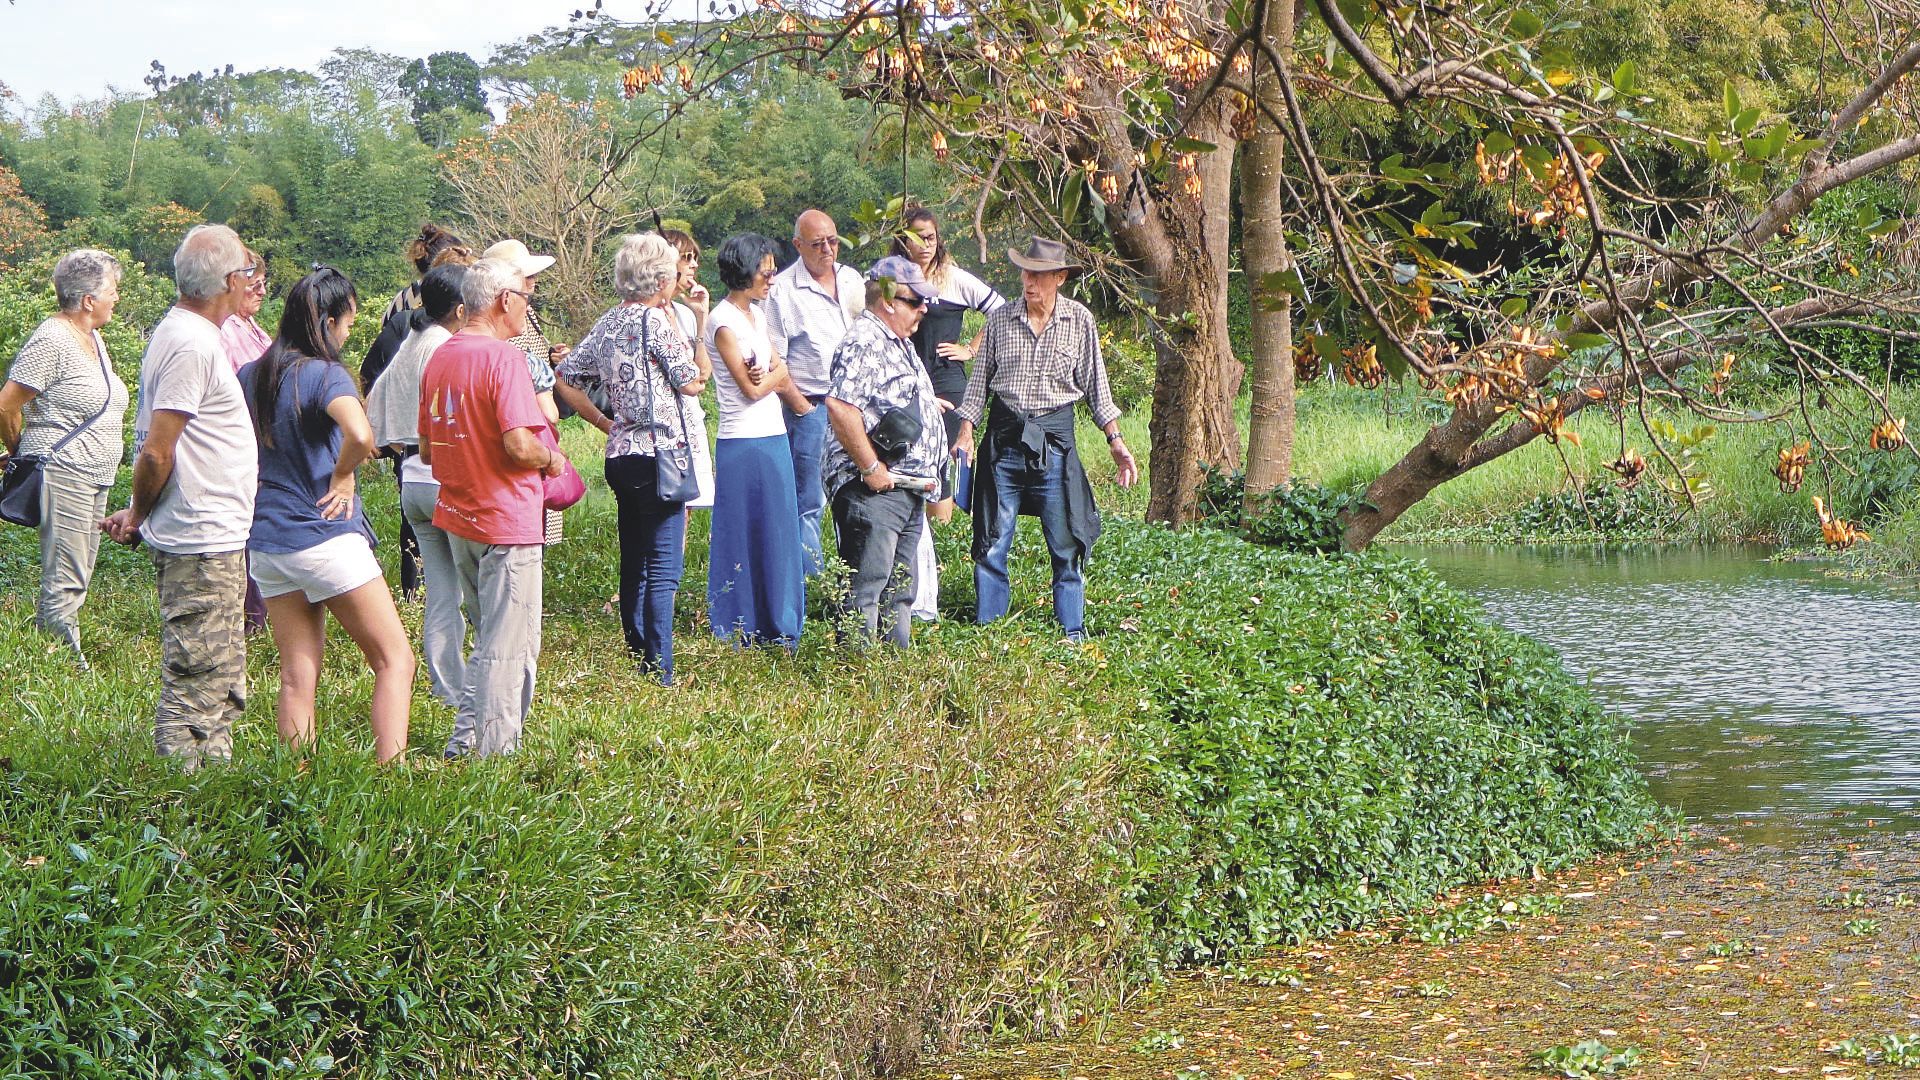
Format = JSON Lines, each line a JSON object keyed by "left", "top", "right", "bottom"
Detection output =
{"left": 707, "top": 233, "right": 806, "bottom": 648}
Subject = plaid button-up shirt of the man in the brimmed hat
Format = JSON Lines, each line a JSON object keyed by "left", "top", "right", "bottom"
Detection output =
{"left": 958, "top": 296, "right": 1119, "bottom": 427}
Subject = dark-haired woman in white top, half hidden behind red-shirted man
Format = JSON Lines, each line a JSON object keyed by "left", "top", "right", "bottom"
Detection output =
{"left": 367, "top": 263, "right": 467, "bottom": 709}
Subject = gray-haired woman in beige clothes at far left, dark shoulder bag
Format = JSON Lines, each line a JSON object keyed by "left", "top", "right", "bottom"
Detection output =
{"left": 0, "top": 248, "right": 127, "bottom": 669}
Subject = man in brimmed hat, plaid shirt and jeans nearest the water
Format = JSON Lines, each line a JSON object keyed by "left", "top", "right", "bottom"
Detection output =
{"left": 954, "top": 236, "right": 1140, "bottom": 642}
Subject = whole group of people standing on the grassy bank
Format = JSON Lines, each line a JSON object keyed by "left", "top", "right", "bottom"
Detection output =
{"left": 0, "top": 209, "right": 1137, "bottom": 769}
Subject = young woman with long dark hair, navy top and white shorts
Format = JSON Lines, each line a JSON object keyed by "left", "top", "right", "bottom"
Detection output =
{"left": 240, "top": 267, "right": 415, "bottom": 763}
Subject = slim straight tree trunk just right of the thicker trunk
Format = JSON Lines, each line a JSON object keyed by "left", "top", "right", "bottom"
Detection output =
{"left": 1240, "top": 0, "right": 1294, "bottom": 513}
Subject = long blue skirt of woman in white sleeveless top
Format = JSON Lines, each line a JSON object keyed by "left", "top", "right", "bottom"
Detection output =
{"left": 707, "top": 434, "right": 806, "bottom": 648}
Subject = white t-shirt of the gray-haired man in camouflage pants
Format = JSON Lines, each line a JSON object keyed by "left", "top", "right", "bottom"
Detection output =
{"left": 134, "top": 307, "right": 259, "bottom": 555}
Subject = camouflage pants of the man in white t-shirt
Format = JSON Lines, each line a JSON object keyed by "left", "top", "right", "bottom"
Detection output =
{"left": 154, "top": 550, "right": 248, "bottom": 769}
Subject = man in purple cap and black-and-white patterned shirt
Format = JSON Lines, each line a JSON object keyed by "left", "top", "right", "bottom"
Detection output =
{"left": 822, "top": 256, "right": 947, "bottom": 646}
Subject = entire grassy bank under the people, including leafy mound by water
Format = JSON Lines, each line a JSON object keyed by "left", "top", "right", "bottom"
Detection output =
{"left": 0, "top": 417, "right": 1653, "bottom": 1078}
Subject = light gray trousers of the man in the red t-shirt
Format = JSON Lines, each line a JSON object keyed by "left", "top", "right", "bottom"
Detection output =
{"left": 447, "top": 536, "right": 545, "bottom": 757}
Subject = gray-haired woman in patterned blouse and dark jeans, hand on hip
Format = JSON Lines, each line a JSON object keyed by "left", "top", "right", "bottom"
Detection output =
{"left": 555, "top": 233, "right": 712, "bottom": 686}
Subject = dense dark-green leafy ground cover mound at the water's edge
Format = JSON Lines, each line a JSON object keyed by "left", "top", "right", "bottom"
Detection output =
{"left": 1098, "top": 527, "right": 1655, "bottom": 957}
